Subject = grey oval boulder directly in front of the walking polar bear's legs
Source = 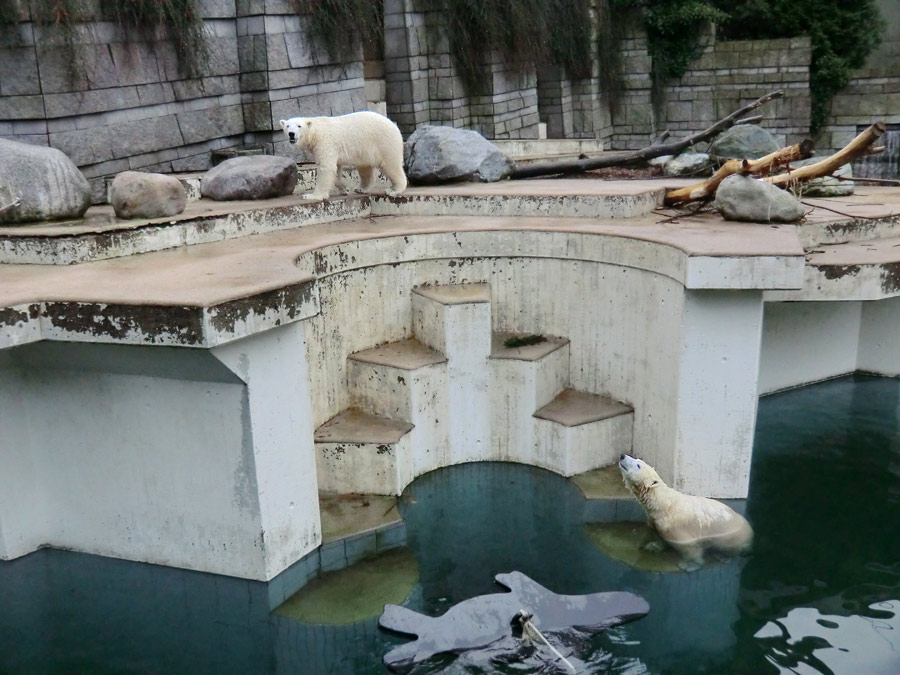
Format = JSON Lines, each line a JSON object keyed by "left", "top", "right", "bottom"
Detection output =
{"left": 200, "top": 155, "right": 297, "bottom": 201}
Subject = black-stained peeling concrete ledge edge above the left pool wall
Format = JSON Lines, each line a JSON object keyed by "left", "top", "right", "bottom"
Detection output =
{"left": 0, "top": 279, "right": 319, "bottom": 349}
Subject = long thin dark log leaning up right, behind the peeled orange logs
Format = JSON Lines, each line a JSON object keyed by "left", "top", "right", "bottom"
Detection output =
{"left": 509, "top": 90, "right": 784, "bottom": 178}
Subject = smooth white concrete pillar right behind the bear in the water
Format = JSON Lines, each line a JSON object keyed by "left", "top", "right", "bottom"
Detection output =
{"left": 672, "top": 290, "right": 763, "bottom": 497}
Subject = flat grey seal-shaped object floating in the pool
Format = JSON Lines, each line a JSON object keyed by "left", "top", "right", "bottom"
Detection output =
{"left": 378, "top": 572, "right": 650, "bottom": 672}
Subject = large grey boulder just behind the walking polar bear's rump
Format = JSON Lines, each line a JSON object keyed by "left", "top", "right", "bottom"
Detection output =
{"left": 403, "top": 125, "right": 516, "bottom": 185}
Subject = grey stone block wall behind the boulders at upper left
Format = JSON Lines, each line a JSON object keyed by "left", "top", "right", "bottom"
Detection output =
{"left": 0, "top": 0, "right": 366, "bottom": 201}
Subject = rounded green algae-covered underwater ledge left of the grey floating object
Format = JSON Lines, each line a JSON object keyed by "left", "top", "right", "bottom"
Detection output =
{"left": 275, "top": 548, "right": 419, "bottom": 625}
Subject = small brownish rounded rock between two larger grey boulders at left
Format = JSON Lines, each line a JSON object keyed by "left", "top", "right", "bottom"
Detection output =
{"left": 109, "top": 171, "right": 187, "bottom": 218}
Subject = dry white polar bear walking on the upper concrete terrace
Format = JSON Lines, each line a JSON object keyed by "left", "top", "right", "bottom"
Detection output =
{"left": 281, "top": 111, "right": 406, "bottom": 199}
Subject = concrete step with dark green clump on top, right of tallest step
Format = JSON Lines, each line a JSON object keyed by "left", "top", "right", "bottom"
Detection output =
{"left": 489, "top": 333, "right": 569, "bottom": 466}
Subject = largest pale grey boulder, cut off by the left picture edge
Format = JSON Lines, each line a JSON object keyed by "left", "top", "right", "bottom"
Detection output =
{"left": 0, "top": 139, "right": 91, "bottom": 223}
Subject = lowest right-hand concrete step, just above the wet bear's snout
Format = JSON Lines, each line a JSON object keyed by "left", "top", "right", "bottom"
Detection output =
{"left": 534, "top": 389, "right": 634, "bottom": 476}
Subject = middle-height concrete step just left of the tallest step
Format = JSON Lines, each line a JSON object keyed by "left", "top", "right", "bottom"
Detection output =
{"left": 347, "top": 338, "right": 447, "bottom": 424}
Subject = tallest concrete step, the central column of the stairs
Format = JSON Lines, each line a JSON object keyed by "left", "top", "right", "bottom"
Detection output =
{"left": 411, "top": 284, "right": 491, "bottom": 464}
